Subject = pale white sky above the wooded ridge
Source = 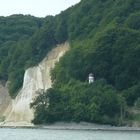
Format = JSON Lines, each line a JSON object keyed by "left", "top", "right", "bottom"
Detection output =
{"left": 0, "top": 0, "right": 80, "bottom": 17}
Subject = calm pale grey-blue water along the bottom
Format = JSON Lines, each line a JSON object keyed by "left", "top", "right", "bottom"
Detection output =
{"left": 0, "top": 128, "right": 140, "bottom": 140}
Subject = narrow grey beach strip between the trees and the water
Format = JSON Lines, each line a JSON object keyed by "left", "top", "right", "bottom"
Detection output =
{"left": 0, "top": 122, "right": 140, "bottom": 132}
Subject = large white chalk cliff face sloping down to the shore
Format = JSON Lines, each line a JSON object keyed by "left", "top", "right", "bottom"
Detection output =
{"left": 4, "top": 43, "right": 69, "bottom": 126}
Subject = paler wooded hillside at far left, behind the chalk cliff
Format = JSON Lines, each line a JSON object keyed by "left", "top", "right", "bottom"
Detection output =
{"left": 0, "top": 15, "right": 44, "bottom": 96}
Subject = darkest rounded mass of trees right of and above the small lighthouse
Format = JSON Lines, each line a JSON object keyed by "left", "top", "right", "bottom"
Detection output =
{"left": 92, "top": 28, "right": 140, "bottom": 89}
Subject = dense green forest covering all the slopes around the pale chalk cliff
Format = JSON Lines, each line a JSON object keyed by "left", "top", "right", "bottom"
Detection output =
{"left": 0, "top": 0, "right": 140, "bottom": 125}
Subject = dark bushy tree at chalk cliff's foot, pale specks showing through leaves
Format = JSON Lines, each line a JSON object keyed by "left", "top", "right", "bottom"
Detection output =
{"left": 31, "top": 89, "right": 61, "bottom": 124}
